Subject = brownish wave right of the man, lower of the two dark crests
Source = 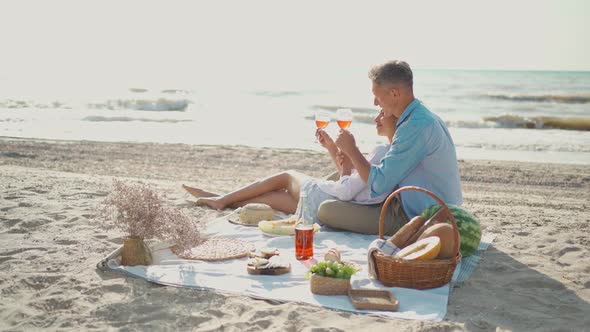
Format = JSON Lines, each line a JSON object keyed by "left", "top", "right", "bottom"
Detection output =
{"left": 484, "top": 115, "right": 590, "bottom": 131}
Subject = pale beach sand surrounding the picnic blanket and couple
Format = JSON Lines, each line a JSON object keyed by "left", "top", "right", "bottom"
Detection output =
{"left": 0, "top": 137, "right": 590, "bottom": 331}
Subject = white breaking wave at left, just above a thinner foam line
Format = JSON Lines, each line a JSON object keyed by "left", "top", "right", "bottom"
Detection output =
{"left": 88, "top": 98, "right": 189, "bottom": 111}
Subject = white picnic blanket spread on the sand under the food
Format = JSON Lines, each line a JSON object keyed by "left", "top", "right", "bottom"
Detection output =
{"left": 103, "top": 218, "right": 493, "bottom": 321}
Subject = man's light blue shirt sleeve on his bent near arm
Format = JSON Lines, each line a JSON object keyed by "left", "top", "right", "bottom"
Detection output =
{"left": 367, "top": 123, "right": 431, "bottom": 198}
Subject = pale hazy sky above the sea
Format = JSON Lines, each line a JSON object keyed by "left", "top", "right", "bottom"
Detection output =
{"left": 0, "top": 0, "right": 590, "bottom": 89}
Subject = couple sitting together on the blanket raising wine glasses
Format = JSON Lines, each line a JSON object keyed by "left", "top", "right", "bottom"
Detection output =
{"left": 183, "top": 61, "right": 463, "bottom": 235}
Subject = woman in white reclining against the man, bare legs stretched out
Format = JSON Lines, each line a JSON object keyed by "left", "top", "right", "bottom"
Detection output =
{"left": 182, "top": 111, "right": 397, "bottom": 222}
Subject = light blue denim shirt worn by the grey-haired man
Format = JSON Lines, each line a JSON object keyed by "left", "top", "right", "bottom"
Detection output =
{"left": 367, "top": 99, "right": 463, "bottom": 218}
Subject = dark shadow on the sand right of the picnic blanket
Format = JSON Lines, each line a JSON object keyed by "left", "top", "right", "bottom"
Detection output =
{"left": 446, "top": 246, "right": 590, "bottom": 331}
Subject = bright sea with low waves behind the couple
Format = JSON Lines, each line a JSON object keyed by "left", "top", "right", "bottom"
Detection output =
{"left": 0, "top": 66, "right": 590, "bottom": 165}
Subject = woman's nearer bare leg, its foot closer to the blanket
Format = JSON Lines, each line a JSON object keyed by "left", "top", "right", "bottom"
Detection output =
{"left": 199, "top": 171, "right": 308, "bottom": 210}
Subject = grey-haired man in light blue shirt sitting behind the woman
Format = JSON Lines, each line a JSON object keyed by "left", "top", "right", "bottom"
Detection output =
{"left": 318, "top": 60, "right": 463, "bottom": 234}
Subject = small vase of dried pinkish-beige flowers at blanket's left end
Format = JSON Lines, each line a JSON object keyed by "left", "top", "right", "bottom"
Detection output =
{"left": 99, "top": 179, "right": 200, "bottom": 265}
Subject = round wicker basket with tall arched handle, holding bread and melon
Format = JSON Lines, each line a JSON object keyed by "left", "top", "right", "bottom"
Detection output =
{"left": 373, "top": 186, "right": 461, "bottom": 289}
